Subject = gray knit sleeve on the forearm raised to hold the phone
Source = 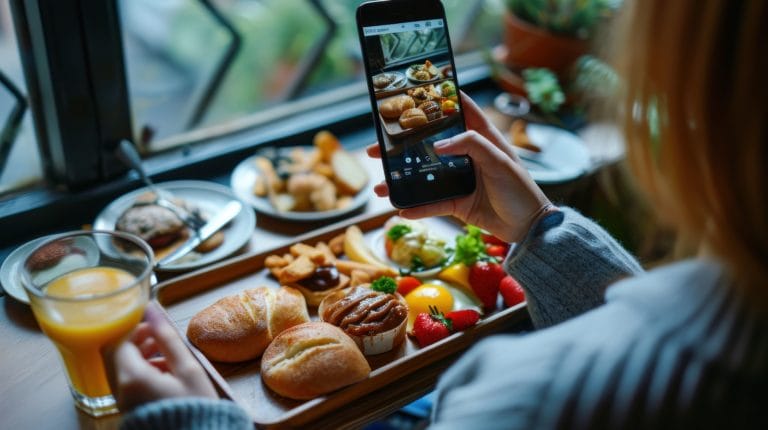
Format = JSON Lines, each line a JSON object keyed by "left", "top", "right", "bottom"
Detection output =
{"left": 504, "top": 208, "right": 643, "bottom": 328}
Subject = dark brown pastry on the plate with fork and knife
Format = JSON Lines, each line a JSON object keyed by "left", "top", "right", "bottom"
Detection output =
{"left": 115, "top": 204, "right": 187, "bottom": 249}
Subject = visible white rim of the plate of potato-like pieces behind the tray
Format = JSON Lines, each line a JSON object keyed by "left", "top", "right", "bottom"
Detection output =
{"left": 230, "top": 148, "right": 373, "bottom": 221}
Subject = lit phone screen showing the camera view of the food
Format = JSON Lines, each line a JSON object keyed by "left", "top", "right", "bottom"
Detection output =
{"left": 363, "top": 19, "right": 471, "bottom": 182}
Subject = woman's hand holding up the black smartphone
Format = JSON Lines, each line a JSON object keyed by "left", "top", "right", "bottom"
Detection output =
{"left": 367, "top": 92, "right": 550, "bottom": 242}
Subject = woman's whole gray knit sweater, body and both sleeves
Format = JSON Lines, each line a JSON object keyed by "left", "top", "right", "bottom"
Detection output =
{"left": 120, "top": 209, "right": 768, "bottom": 429}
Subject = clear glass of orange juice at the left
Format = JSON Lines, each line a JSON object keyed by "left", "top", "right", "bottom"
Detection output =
{"left": 20, "top": 231, "right": 154, "bottom": 416}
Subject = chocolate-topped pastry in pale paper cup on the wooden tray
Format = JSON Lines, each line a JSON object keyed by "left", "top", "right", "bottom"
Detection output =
{"left": 318, "top": 284, "right": 408, "bottom": 355}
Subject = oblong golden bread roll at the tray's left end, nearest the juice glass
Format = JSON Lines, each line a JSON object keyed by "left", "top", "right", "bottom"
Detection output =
{"left": 187, "top": 287, "right": 309, "bottom": 363}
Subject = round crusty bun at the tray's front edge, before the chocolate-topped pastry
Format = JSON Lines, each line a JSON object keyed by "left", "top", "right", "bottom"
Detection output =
{"left": 261, "top": 322, "right": 371, "bottom": 400}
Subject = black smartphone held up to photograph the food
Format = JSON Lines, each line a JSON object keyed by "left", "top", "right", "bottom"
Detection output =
{"left": 357, "top": 0, "right": 475, "bottom": 208}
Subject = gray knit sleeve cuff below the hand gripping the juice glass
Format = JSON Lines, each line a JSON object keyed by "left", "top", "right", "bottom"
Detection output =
{"left": 120, "top": 397, "right": 254, "bottom": 430}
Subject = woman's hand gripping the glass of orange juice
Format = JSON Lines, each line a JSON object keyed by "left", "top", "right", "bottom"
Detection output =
{"left": 105, "top": 303, "right": 218, "bottom": 412}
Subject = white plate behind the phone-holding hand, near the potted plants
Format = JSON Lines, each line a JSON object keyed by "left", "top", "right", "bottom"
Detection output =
{"left": 513, "top": 124, "right": 591, "bottom": 184}
